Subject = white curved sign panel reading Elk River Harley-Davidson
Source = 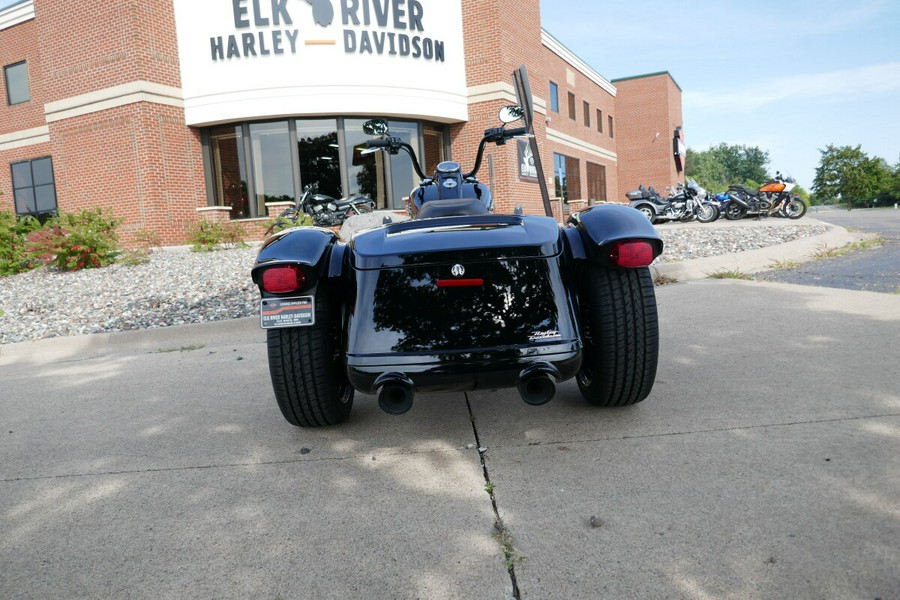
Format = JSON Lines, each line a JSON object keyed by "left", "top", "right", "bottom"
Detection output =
{"left": 175, "top": 0, "right": 468, "bottom": 125}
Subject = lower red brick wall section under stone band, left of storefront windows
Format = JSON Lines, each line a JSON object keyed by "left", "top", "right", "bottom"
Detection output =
{"left": 50, "top": 102, "right": 206, "bottom": 244}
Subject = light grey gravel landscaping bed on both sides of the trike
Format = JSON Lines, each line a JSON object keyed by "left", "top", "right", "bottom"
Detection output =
{"left": 0, "top": 223, "right": 827, "bottom": 344}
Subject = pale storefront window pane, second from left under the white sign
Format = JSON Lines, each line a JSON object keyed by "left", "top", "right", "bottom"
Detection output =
{"left": 250, "top": 121, "right": 294, "bottom": 216}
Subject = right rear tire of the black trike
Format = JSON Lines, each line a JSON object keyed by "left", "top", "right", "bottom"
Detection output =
{"left": 576, "top": 264, "right": 659, "bottom": 406}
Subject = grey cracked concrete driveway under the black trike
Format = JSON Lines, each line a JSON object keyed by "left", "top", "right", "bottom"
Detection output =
{"left": 0, "top": 281, "right": 900, "bottom": 600}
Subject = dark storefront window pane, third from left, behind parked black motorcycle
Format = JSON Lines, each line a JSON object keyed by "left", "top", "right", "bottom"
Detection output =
{"left": 296, "top": 119, "right": 344, "bottom": 198}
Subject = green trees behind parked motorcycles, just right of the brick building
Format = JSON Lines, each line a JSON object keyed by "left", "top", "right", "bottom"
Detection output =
{"left": 685, "top": 143, "right": 769, "bottom": 192}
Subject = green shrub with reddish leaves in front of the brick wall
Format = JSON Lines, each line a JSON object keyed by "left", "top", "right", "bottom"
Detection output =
{"left": 27, "top": 208, "right": 122, "bottom": 271}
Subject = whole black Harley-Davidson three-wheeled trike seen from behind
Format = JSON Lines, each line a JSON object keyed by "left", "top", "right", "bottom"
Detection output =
{"left": 252, "top": 107, "right": 663, "bottom": 427}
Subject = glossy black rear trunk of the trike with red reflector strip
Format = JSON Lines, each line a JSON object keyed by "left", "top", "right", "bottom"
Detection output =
{"left": 347, "top": 215, "right": 578, "bottom": 362}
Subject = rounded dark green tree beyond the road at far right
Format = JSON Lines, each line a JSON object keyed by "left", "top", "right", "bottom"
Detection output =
{"left": 813, "top": 144, "right": 892, "bottom": 210}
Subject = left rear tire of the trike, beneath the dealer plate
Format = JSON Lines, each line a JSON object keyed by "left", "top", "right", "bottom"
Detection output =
{"left": 267, "top": 284, "right": 353, "bottom": 427}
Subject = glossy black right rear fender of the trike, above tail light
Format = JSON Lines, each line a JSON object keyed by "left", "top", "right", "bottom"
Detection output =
{"left": 566, "top": 204, "right": 663, "bottom": 266}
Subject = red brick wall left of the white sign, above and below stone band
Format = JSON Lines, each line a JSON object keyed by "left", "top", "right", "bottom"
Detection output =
{"left": 0, "top": 0, "right": 206, "bottom": 244}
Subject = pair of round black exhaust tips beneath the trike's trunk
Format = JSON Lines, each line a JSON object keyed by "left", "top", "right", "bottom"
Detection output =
{"left": 375, "top": 363, "right": 559, "bottom": 415}
